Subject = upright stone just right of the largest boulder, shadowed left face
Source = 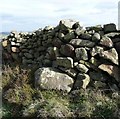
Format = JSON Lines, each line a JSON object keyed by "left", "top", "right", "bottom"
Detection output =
{"left": 74, "top": 73, "right": 90, "bottom": 89}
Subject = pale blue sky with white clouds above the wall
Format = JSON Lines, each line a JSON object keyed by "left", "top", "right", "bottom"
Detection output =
{"left": 0, "top": 0, "right": 120, "bottom": 32}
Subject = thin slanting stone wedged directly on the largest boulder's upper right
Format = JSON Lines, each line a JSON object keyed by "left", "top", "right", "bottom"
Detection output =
{"left": 58, "top": 67, "right": 77, "bottom": 78}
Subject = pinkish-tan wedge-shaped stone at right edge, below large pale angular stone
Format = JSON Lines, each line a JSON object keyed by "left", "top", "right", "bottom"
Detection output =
{"left": 98, "top": 64, "right": 120, "bottom": 82}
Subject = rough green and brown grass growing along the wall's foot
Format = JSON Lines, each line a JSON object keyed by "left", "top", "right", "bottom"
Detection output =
{"left": 2, "top": 65, "right": 120, "bottom": 119}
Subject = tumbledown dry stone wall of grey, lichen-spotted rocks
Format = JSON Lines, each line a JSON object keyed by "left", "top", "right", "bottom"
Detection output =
{"left": 2, "top": 20, "right": 120, "bottom": 92}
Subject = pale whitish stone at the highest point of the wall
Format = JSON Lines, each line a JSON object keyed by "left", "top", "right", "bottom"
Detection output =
{"left": 59, "top": 19, "right": 76, "bottom": 30}
